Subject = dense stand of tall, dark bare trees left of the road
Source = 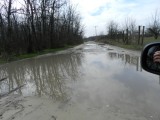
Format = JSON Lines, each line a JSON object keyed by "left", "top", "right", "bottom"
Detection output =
{"left": 0, "top": 0, "right": 84, "bottom": 59}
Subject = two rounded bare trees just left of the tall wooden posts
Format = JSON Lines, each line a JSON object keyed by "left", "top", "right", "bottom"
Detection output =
{"left": 107, "top": 17, "right": 139, "bottom": 44}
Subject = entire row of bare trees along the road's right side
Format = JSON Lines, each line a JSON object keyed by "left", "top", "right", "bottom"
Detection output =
{"left": 107, "top": 11, "right": 160, "bottom": 45}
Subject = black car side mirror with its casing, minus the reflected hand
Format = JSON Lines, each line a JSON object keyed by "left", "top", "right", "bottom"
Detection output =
{"left": 141, "top": 42, "right": 160, "bottom": 75}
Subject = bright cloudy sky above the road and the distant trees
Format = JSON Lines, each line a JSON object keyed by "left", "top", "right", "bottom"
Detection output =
{"left": 70, "top": 0, "right": 160, "bottom": 37}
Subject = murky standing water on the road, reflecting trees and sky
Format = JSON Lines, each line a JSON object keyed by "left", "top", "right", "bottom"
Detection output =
{"left": 0, "top": 43, "right": 160, "bottom": 120}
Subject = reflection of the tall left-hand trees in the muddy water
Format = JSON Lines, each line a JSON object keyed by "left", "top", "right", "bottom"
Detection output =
{"left": 0, "top": 53, "right": 83, "bottom": 100}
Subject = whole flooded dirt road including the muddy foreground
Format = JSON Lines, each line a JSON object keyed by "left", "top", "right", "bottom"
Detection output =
{"left": 0, "top": 42, "right": 160, "bottom": 120}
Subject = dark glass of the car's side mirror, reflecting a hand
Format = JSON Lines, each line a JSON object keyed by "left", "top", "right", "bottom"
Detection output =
{"left": 146, "top": 46, "right": 160, "bottom": 73}
